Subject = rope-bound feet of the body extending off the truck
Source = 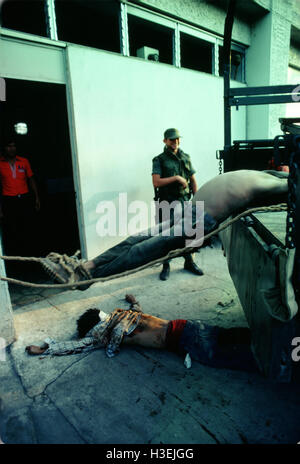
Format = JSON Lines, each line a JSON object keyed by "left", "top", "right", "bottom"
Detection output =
{"left": 41, "top": 253, "right": 92, "bottom": 290}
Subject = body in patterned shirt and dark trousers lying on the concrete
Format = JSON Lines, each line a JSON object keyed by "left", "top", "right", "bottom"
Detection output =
{"left": 26, "top": 295, "right": 257, "bottom": 371}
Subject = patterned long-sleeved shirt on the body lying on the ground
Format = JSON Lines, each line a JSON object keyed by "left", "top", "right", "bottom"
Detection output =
{"left": 43, "top": 307, "right": 142, "bottom": 358}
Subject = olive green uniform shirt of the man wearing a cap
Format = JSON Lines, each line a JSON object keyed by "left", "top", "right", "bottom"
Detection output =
{"left": 152, "top": 147, "right": 196, "bottom": 202}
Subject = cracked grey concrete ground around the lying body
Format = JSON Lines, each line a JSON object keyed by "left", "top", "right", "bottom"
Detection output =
{"left": 0, "top": 248, "right": 300, "bottom": 444}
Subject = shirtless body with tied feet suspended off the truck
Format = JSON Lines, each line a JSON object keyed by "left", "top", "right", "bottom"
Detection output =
{"left": 42, "top": 170, "right": 288, "bottom": 289}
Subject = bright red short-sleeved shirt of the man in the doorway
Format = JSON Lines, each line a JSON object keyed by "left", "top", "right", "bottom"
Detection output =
{"left": 0, "top": 156, "right": 33, "bottom": 196}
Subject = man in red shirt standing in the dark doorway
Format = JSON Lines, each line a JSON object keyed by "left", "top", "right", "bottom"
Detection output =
{"left": 0, "top": 139, "right": 40, "bottom": 264}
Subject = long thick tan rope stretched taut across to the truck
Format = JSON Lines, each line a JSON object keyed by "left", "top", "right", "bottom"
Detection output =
{"left": 0, "top": 203, "right": 287, "bottom": 288}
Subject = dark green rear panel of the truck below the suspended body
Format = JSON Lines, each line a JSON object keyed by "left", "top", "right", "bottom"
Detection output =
{"left": 220, "top": 211, "right": 300, "bottom": 382}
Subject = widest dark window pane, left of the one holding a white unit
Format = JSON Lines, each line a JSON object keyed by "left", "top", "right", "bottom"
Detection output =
{"left": 55, "top": 0, "right": 120, "bottom": 53}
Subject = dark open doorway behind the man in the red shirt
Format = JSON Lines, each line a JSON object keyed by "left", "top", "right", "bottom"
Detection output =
{"left": 1, "top": 79, "right": 80, "bottom": 276}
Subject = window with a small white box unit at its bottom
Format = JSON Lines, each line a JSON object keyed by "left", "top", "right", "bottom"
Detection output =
{"left": 128, "top": 14, "right": 174, "bottom": 64}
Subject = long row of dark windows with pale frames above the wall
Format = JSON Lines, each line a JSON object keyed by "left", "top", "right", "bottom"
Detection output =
{"left": 0, "top": 0, "right": 245, "bottom": 82}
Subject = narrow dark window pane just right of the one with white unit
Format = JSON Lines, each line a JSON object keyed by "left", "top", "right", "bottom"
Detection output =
{"left": 180, "top": 32, "right": 213, "bottom": 74}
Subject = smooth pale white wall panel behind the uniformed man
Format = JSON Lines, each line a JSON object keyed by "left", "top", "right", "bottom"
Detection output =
{"left": 67, "top": 45, "right": 245, "bottom": 257}
